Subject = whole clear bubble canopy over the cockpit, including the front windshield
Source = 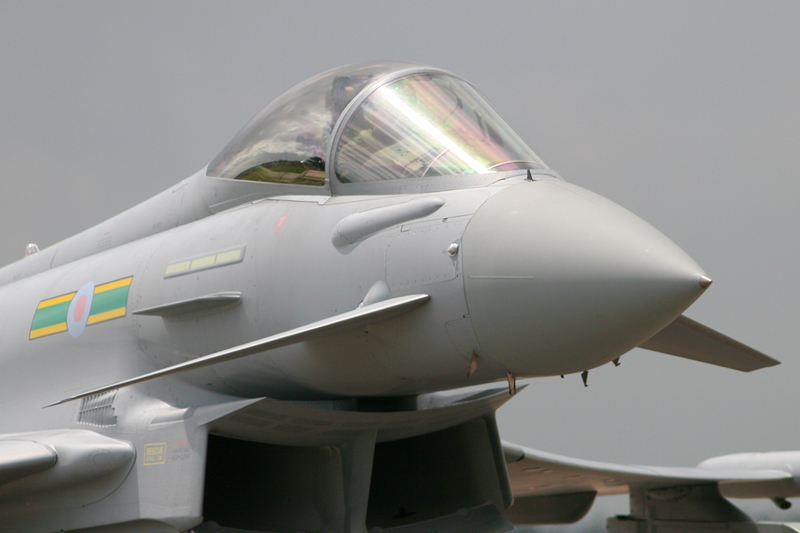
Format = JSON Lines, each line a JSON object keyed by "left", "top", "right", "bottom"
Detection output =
{"left": 208, "top": 63, "right": 547, "bottom": 192}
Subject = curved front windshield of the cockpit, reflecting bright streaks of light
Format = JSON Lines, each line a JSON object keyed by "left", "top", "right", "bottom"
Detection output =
{"left": 335, "top": 73, "right": 547, "bottom": 183}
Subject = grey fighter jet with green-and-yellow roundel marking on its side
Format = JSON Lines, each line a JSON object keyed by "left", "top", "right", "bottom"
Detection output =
{"left": 0, "top": 62, "right": 797, "bottom": 533}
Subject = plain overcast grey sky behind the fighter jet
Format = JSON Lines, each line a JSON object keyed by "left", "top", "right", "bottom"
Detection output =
{"left": 0, "top": 0, "right": 800, "bottom": 528}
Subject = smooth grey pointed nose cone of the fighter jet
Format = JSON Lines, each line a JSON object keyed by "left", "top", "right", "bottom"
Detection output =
{"left": 462, "top": 180, "right": 711, "bottom": 376}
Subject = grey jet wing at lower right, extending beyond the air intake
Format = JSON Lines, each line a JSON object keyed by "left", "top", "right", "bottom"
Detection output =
{"left": 503, "top": 442, "right": 800, "bottom": 524}
